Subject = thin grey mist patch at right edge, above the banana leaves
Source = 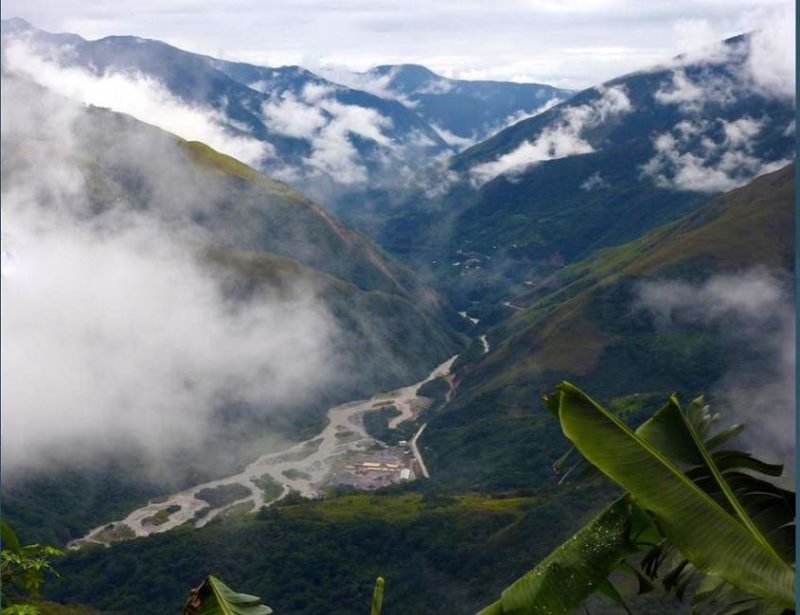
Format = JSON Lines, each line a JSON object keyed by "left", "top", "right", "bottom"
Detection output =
{"left": 638, "top": 268, "right": 796, "bottom": 474}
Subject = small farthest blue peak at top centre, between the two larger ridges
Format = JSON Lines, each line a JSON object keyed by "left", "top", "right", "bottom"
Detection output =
{"left": 331, "top": 64, "right": 574, "bottom": 149}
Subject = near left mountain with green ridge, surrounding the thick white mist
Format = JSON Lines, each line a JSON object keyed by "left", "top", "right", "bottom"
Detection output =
{"left": 2, "top": 76, "right": 460, "bottom": 542}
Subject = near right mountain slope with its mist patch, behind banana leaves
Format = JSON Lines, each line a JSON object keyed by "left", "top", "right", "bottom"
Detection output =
{"left": 422, "top": 165, "right": 795, "bottom": 488}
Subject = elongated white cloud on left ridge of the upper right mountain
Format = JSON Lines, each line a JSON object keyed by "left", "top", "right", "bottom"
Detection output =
{"left": 470, "top": 86, "right": 632, "bottom": 185}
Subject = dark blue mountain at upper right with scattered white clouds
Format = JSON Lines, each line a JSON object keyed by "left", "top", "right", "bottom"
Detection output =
{"left": 380, "top": 33, "right": 795, "bottom": 308}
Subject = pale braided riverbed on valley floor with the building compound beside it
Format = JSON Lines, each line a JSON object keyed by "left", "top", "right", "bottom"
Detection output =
{"left": 69, "top": 356, "right": 457, "bottom": 549}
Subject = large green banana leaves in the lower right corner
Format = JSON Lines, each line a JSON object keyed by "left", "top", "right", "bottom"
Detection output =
{"left": 483, "top": 382, "right": 795, "bottom": 615}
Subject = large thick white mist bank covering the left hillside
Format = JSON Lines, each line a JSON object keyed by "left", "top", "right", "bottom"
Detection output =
{"left": 0, "top": 77, "right": 338, "bottom": 479}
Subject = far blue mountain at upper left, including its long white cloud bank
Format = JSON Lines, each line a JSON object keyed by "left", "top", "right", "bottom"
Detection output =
{"left": 3, "top": 19, "right": 448, "bottom": 207}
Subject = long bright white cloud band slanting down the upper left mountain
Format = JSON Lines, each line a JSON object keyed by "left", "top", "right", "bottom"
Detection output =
{"left": 5, "top": 40, "right": 274, "bottom": 165}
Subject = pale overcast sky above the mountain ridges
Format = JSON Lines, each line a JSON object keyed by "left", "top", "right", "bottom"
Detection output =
{"left": 2, "top": 0, "right": 794, "bottom": 89}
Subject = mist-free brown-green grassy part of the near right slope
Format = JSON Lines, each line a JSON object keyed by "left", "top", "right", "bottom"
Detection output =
{"left": 421, "top": 165, "right": 794, "bottom": 488}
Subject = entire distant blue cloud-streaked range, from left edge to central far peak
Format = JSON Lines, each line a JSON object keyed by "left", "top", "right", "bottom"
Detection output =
{"left": 2, "top": 19, "right": 570, "bottom": 217}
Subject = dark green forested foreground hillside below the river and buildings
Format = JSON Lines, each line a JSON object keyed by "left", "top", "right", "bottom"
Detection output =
{"left": 46, "top": 483, "right": 607, "bottom": 615}
